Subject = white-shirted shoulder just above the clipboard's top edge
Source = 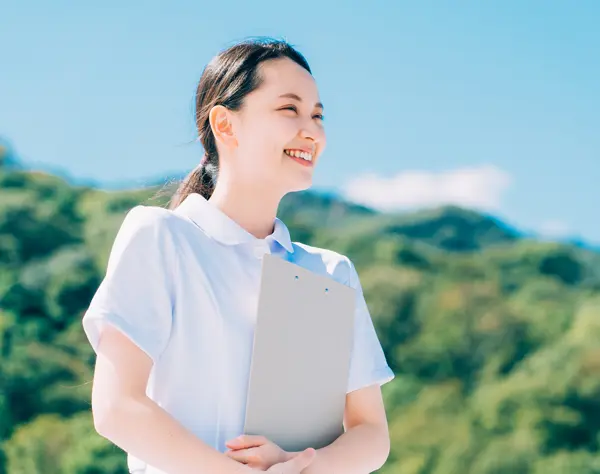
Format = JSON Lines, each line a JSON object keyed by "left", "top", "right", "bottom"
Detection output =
{"left": 293, "top": 242, "right": 358, "bottom": 288}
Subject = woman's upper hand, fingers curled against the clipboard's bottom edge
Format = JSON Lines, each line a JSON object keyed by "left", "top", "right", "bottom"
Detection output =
{"left": 225, "top": 435, "right": 292, "bottom": 471}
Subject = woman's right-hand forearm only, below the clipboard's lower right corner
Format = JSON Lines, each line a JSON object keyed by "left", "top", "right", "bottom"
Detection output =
{"left": 290, "top": 423, "right": 390, "bottom": 474}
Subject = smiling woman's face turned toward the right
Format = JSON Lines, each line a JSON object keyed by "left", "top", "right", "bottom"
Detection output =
{"left": 224, "top": 58, "right": 325, "bottom": 194}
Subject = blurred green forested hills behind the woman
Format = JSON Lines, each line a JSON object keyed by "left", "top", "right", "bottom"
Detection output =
{"left": 0, "top": 153, "right": 600, "bottom": 474}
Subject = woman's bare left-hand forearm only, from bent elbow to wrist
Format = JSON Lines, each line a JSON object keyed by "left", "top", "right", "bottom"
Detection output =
{"left": 97, "top": 397, "right": 246, "bottom": 474}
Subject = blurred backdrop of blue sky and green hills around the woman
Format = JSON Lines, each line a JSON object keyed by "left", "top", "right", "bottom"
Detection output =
{"left": 0, "top": 0, "right": 600, "bottom": 474}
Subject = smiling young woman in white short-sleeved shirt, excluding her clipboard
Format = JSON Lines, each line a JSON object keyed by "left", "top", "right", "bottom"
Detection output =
{"left": 83, "top": 40, "right": 393, "bottom": 474}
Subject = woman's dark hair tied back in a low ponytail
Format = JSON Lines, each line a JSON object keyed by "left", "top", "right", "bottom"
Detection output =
{"left": 169, "top": 38, "right": 312, "bottom": 208}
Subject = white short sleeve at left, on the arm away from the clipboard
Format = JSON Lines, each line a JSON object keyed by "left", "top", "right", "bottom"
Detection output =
{"left": 82, "top": 206, "right": 173, "bottom": 363}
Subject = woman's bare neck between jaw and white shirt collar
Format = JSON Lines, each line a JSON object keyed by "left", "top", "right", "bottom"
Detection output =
{"left": 210, "top": 179, "right": 282, "bottom": 239}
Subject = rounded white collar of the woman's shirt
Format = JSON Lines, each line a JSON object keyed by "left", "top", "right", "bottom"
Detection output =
{"left": 175, "top": 193, "right": 294, "bottom": 253}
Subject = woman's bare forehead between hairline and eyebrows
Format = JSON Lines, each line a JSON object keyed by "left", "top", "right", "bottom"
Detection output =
{"left": 254, "top": 58, "right": 320, "bottom": 103}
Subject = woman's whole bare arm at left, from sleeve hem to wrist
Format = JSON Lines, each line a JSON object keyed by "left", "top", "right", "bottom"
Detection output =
{"left": 92, "top": 325, "right": 248, "bottom": 474}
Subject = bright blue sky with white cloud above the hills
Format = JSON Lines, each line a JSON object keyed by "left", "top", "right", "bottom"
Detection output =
{"left": 0, "top": 0, "right": 600, "bottom": 243}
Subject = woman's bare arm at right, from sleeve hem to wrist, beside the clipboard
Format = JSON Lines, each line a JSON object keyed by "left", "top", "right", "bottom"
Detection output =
{"left": 290, "top": 384, "right": 390, "bottom": 474}
